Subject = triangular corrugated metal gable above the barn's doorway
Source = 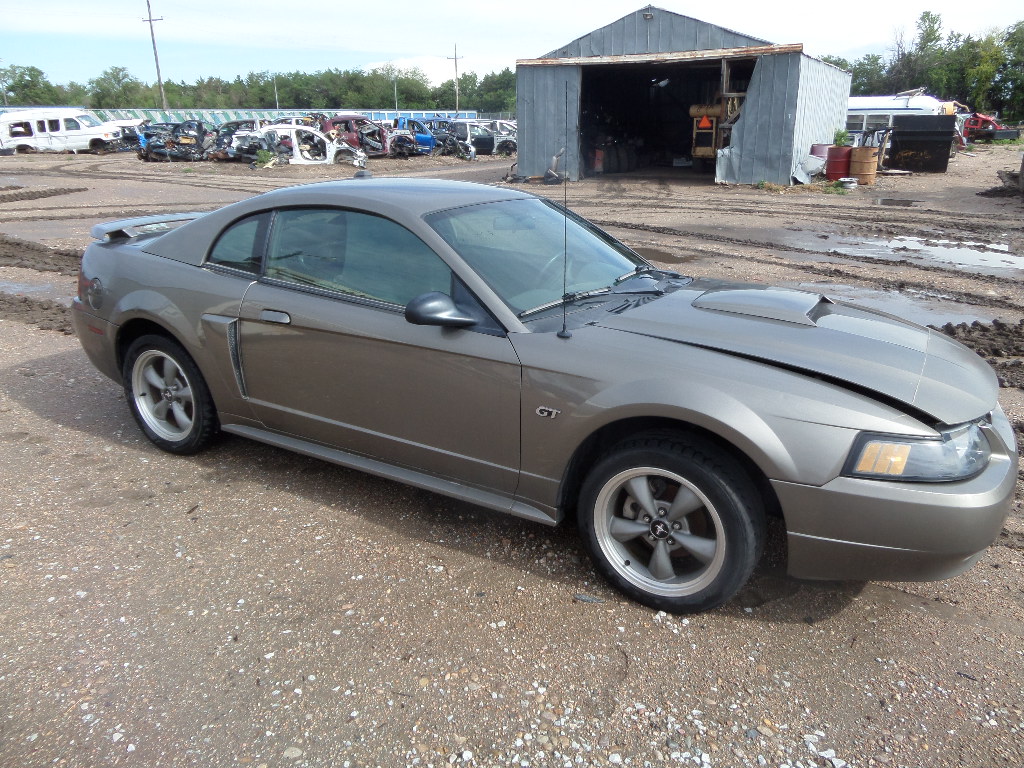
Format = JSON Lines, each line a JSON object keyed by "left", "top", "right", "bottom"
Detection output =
{"left": 544, "top": 5, "right": 768, "bottom": 57}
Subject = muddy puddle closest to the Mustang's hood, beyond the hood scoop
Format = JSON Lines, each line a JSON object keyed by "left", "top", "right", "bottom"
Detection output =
{"left": 782, "top": 283, "right": 999, "bottom": 326}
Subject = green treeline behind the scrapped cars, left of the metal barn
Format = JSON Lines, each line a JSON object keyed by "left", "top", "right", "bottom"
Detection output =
{"left": 0, "top": 65, "right": 515, "bottom": 113}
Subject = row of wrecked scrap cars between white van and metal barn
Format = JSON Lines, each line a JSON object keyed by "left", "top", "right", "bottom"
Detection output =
{"left": 137, "top": 113, "right": 518, "bottom": 168}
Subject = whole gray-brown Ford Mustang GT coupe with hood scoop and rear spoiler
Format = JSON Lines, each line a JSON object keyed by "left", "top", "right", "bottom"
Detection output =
{"left": 73, "top": 178, "right": 1017, "bottom": 612}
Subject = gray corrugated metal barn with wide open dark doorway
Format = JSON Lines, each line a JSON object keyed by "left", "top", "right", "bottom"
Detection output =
{"left": 516, "top": 5, "right": 850, "bottom": 184}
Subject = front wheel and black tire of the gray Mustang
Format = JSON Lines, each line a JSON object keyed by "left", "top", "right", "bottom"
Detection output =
{"left": 578, "top": 434, "right": 765, "bottom": 613}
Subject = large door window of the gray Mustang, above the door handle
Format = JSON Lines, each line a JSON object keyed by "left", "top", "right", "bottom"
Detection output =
{"left": 266, "top": 208, "right": 452, "bottom": 305}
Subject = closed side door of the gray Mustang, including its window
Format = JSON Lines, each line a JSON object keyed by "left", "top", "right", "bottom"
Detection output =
{"left": 240, "top": 208, "right": 520, "bottom": 494}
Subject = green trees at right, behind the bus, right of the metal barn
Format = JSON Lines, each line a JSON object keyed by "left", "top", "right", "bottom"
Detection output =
{"left": 822, "top": 11, "right": 1024, "bottom": 122}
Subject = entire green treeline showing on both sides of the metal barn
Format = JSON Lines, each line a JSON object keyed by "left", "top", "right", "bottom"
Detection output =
{"left": 0, "top": 11, "right": 1024, "bottom": 122}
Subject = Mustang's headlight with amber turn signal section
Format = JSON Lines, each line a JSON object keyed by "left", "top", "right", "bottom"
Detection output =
{"left": 843, "top": 423, "right": 991, "bottom": 482}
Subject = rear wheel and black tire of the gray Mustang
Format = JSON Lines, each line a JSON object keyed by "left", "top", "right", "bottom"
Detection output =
{"left": 121, "top": 335, "right": 220, "bottom": 455}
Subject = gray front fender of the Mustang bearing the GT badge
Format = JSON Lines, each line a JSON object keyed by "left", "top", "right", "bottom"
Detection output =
{"left": 514, "top": 328, "right": 929, "bottom": 512}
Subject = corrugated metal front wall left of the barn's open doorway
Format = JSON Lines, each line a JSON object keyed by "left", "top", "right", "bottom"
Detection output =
{"left": 516, "top": 67, "right": 583, "bottom": 181}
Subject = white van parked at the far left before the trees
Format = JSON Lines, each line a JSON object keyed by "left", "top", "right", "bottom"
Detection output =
{"left": 0, "top": 106, "right": 121, "bottom": 153}
